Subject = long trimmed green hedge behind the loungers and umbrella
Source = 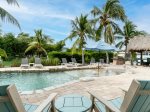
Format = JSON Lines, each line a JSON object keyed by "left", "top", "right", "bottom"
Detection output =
{"left": 48, "top": 51, "right": 113, "bottom": 63}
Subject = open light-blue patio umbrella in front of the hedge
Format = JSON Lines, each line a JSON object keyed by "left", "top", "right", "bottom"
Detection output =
{"left": 86, "top": 41, "right": 119, "bottom": 63}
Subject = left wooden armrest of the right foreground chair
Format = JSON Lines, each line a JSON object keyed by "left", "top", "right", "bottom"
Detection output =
{"left": 88, "top": 91, "right": 121, "bottom": 112}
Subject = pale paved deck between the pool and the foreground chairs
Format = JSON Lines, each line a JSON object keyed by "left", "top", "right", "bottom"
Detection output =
{"left": 20, "top": 65, "right": 150, "bottom": 104}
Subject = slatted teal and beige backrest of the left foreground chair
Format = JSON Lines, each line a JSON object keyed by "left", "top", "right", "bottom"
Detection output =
{"left": 0, "top": 85, "right": 26, "bottom": 112}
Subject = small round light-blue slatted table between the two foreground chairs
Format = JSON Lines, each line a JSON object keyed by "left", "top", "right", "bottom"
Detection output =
{"left": 55, "top": 94, "right": 92, "bottom": 112}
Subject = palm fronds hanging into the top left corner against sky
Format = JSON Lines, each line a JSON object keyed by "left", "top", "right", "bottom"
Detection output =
{"left": 0, "top": 0, "right": 21, "bottom": 29}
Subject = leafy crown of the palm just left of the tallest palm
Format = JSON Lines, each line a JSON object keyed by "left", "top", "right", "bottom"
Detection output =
{"left": 65, "top": 14, "right": 94, "bottom": 50}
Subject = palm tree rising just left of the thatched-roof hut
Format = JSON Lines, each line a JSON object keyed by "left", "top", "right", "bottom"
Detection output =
{"left": 116, "top": 20, "right": 146, "bottom": 58}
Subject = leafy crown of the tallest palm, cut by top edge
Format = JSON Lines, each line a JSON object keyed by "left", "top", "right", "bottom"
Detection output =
{"left": 91, "top": 0, "right": 126, "bottom": 44}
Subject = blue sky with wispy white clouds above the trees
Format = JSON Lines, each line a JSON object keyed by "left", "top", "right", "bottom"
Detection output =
{"left": 0, "top": 0, "right": 150, "bottom": 47}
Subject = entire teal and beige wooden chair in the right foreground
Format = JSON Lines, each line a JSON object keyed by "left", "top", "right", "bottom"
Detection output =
{"left": 89, "top": 80, "right": 150, "bottom": 112}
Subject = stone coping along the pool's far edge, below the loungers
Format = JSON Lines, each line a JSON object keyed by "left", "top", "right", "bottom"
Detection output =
{"left": 0, "top": 65, "right": 102, "bottom": 73}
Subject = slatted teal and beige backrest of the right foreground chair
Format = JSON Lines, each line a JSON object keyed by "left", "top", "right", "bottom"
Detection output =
{"left": 120, "top": 80, "right": 150, "bottom": 112}
